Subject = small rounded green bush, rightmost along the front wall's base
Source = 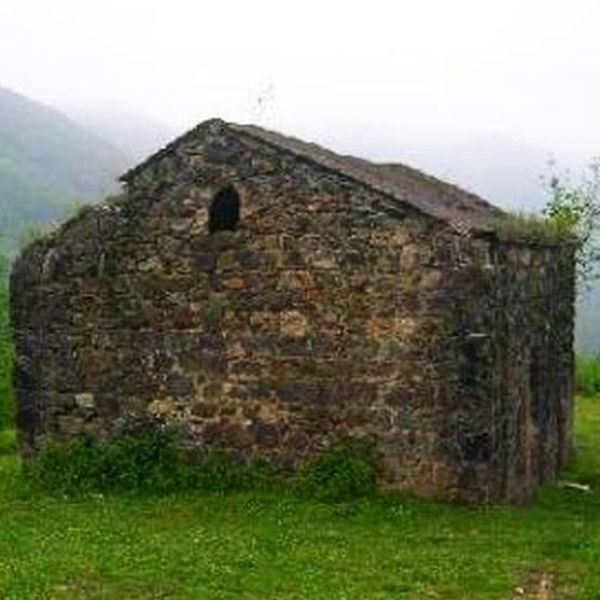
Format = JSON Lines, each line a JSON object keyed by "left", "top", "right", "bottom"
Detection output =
{"left": 296, "top": 438, "right": 377, "bottom": 502}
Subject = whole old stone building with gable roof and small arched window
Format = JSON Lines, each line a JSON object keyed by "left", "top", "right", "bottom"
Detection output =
{"left": 11, "top": 119, "right": 574, "bottom": 502}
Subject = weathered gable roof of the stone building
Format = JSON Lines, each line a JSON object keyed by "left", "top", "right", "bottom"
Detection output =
{"left": 120, "top": 119, "right": 505, "bottom": 231}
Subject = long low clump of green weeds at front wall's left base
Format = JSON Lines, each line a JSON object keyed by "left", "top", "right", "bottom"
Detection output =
{"left": 27, "top": 428, "right": 286, "bottom": 496}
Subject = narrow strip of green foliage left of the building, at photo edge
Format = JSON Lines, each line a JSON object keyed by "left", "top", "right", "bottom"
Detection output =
{"left": 0, "top": 246, "right": 14, "bottom": 431}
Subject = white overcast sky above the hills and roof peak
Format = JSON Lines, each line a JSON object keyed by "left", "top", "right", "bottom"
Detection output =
{"left": 0, "top": 0, "right": 600, "bottom": 162}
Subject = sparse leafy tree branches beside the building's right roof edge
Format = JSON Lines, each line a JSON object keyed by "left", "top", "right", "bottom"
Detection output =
{"left": 544, "top": 159, "right": 600, "bottom": 284}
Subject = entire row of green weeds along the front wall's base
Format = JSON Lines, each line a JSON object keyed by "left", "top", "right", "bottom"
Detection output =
{"left": 25, "top": 429, "right": 376, "bottom": 502}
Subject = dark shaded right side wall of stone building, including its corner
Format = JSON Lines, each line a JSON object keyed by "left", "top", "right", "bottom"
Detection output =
{"left": 440, "top": 234, "right": 575, "bottom": 502}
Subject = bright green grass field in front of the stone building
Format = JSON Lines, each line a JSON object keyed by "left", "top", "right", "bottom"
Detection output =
{"left": 0, "top": 398, "right": 600, "bottom": 600}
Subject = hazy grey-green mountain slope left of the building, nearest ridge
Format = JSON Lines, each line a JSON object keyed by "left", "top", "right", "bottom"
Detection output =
{"left": 0, "top": 87, "right": 130, "bottom": 250}
